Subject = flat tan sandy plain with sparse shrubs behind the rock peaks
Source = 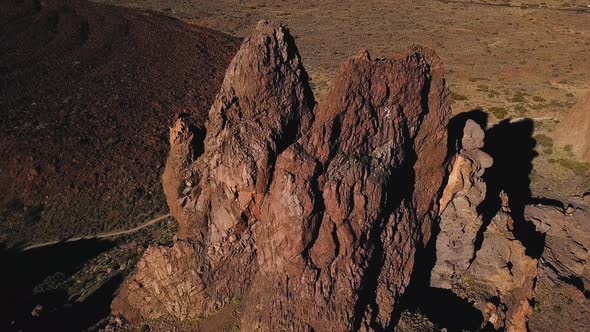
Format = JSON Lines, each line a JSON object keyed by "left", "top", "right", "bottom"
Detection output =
{"left": 97, "top": 0, "right": 590, "bottom": 195}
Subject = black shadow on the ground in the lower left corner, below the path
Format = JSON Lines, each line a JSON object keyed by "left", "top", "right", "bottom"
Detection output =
{"left": 0, "top": 240, "right": 122, "bottom": 331}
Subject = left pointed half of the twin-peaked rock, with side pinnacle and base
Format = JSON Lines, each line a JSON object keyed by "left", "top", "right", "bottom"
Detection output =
{"left": 113, "top": 22, "right": 313, "bottom": 320}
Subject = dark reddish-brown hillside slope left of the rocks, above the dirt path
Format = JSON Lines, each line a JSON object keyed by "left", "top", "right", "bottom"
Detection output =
{"left": 0, "top": 0, "right": 239, "bottom": 246}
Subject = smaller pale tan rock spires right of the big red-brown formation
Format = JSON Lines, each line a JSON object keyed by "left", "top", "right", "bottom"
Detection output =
{"left": 430, "top": 120, "right": 537, "bottom": 331}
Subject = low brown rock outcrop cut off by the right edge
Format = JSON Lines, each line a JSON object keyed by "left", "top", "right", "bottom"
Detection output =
{"left": 525, "top": 193, "right": 590, "bottom": 331}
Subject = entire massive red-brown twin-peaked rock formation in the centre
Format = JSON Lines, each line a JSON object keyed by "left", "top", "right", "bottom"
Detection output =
{"left": 113, "top": 22, "right": 450, "bottom": 331}
